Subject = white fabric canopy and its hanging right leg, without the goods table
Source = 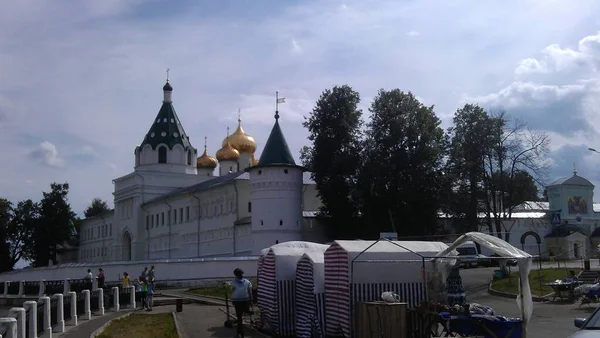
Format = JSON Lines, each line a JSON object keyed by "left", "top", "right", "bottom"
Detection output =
{"left": 436, "top": 232, "right": 533, "bottom": 338}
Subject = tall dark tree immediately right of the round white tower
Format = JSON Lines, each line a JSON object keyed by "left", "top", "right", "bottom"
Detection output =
{"left": 301, "top": 85, "right": 364, "bottom": 239}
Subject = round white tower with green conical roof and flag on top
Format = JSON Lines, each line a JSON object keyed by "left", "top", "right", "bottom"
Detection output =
{"left": 246, "top": 111, "right": 305, "bottom": 254}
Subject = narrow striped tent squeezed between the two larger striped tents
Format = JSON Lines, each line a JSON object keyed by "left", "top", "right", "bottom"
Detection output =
{"left": 296, "top": 252, "right": 325, "bottom": 338}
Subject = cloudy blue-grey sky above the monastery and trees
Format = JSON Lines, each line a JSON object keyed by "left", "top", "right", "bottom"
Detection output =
{"left": 0, "top": 0, "right": 600, "bottom": 215}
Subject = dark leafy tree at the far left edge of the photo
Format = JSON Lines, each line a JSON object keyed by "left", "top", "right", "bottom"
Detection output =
{"left": 6, "top": 200, "right": 40, "bottom": 269}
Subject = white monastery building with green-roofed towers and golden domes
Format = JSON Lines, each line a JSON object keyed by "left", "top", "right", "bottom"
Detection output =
{"left": 78, "top": 81, "right": 325, "bottom": 262}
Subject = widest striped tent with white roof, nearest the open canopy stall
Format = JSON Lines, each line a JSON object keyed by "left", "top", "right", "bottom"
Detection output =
{"left": 325, "top": 240, "right": 448, "bottom": 337}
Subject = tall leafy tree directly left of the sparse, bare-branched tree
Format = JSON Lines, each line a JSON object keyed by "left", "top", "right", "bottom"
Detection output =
{"left": 447, "top": 104, "right": 493, "bottom": 232}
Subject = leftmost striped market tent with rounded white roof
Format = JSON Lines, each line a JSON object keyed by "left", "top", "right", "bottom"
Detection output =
{"left": 258, "top": 243, "right": 327, "bottom": 337}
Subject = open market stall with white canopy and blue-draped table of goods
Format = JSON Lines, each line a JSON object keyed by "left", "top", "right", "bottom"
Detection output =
{"left": 436, "top": 232, "right": 533, "bottom": 338}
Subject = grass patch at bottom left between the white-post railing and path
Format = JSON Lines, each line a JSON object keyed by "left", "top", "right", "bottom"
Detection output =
{"left": 97, "top": 313, "right": 179, "bottom": 338}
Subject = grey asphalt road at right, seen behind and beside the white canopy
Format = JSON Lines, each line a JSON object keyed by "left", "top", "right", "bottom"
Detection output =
{"left": 461, "top": 268, "right": 594, "bottom": 338}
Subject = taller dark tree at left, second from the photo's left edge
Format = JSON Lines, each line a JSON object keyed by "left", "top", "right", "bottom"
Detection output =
{"left": 31, "top": 183, "right": 75, "bottom": 266}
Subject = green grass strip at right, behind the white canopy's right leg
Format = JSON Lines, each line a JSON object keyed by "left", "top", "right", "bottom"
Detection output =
{"left": 492, "top": 268, "right": 579, "bottom": 296}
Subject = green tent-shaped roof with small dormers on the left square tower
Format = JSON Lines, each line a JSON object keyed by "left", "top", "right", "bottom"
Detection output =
{"left": 140, "top": 82, "right": 193, "bottom": 150}
